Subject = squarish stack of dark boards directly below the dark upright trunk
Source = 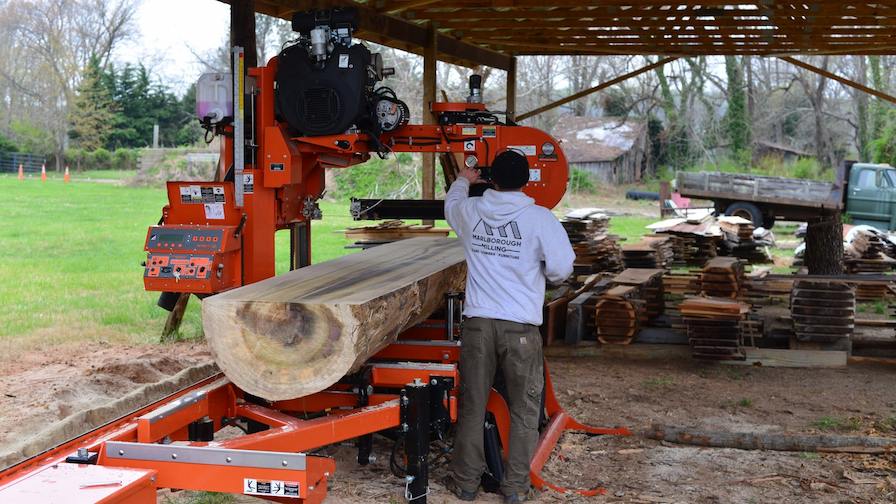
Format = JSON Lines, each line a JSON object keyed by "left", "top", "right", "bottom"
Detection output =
{"left": 790, "top": 279, "right": 856, "bottom": 344}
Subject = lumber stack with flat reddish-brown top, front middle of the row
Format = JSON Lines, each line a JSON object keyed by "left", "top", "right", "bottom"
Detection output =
{"left": 679, "top": 297, "right": 750, "bottom": 360}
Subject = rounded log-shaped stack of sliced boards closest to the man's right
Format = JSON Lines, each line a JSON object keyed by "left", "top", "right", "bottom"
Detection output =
{"left": 594, "top": 285, "right": 647, "bottom": 345}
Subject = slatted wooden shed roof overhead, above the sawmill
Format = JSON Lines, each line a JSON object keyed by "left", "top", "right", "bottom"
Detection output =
{"left": 240, "top": 0, "right": 896, "bottom": 68}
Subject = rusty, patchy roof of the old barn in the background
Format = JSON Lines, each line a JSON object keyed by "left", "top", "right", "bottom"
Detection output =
{"left": 551, "top": 116, "right": 647, "bottom": 163}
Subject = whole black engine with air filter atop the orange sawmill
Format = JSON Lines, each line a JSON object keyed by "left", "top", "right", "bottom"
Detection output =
{"left": 276, "top": 8, "right": 410, "bottom": 136}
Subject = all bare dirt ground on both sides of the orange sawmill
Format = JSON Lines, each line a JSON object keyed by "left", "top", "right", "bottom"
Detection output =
{"left": 0, "top": 344, "right": 896, "bottom": 504}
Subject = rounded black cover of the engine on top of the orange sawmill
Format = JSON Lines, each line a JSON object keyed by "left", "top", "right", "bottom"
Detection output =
{"left": 276, "top": 44, "right": 371, "bottom": 136}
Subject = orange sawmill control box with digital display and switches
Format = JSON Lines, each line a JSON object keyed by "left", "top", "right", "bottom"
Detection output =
{"left": 143, "top": 225, "right": 240, "bottom": 294}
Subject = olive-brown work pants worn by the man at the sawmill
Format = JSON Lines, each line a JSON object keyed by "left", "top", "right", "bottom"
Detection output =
{"left": 452, "top": 318, "right": 544, "bottom": 495}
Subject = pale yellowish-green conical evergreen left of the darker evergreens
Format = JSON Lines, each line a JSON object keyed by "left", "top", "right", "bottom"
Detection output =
{"left": 69, "top": 56, "right": 115, "bottom": 151}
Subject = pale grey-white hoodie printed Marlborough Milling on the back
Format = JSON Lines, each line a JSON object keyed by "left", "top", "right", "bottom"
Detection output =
{"left": 445, "top": 177, "right": 575, "bottom": 325}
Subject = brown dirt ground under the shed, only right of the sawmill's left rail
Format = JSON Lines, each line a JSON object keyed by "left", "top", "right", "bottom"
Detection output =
{"left": 178, "top": 357, "right": 896, "bottom": 504}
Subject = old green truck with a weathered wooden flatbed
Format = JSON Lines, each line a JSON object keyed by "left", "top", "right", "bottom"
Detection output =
{"left": 676, "top": 161, "right": 896, "bottom": 230}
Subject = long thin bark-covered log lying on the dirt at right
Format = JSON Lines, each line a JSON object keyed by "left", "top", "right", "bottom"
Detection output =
{"left": 644, "top": 424, "right": 896, "bottom": 453}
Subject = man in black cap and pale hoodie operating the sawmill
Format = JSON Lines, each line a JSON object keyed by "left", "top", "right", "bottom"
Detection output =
{"left": 445, "top": 150, "right": 575, "bottom": 503}
